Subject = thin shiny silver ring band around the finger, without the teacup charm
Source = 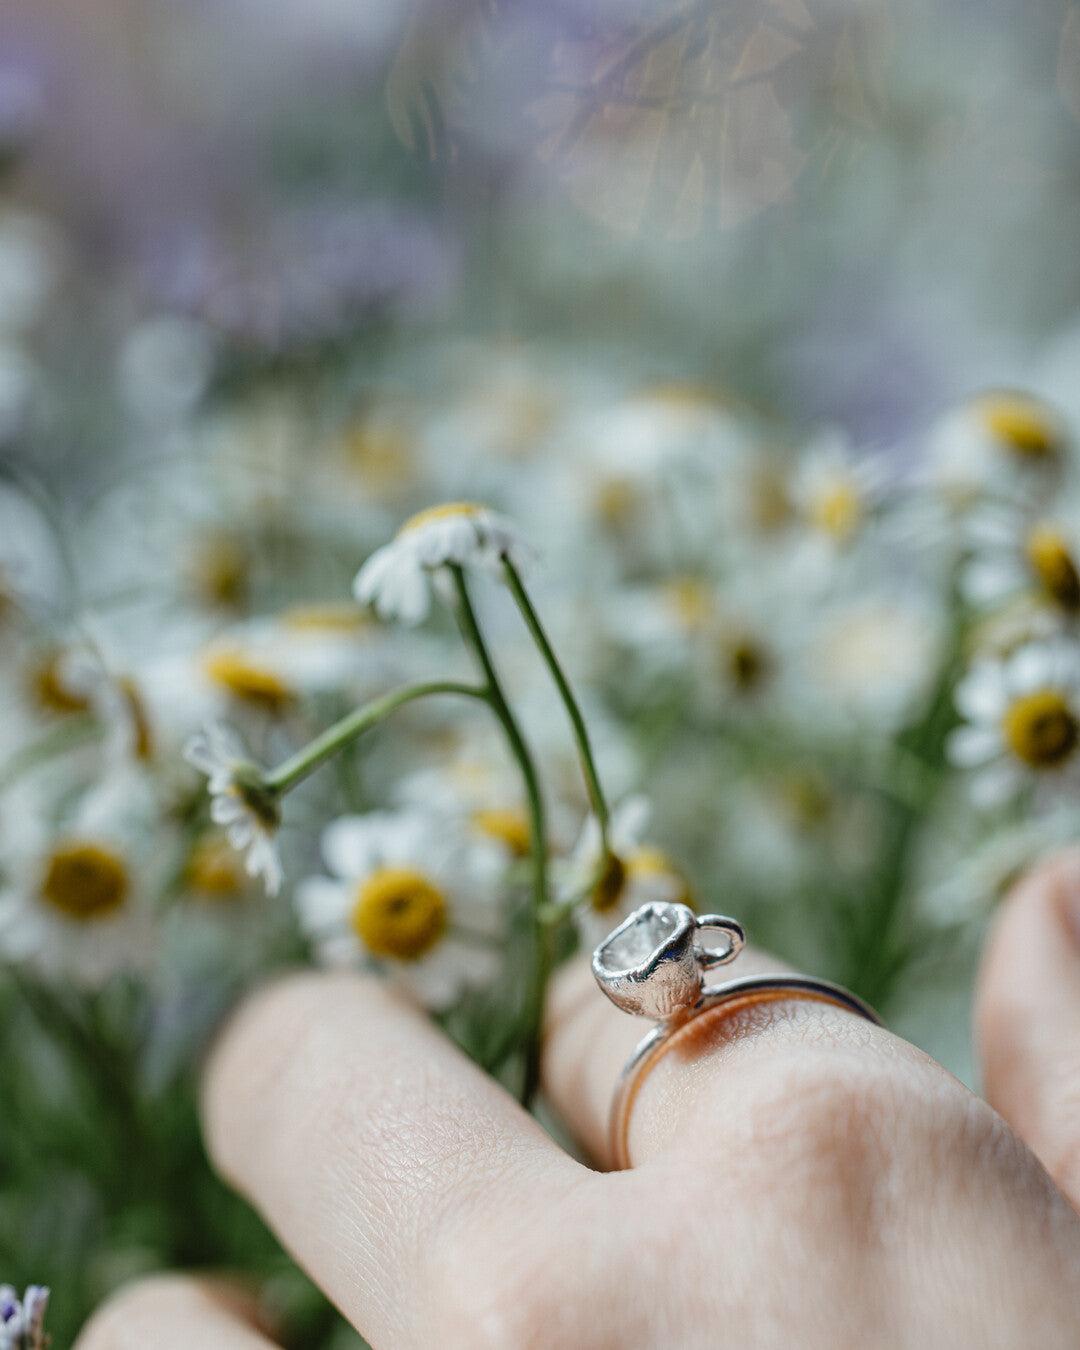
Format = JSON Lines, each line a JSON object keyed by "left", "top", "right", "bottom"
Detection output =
{"left": 610, "top": 975, "right": 882, "bottom": 1172}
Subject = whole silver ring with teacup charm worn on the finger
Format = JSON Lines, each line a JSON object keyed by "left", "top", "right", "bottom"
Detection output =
{"left": 593, "top": 902, "right": 882, "bottom": 1169}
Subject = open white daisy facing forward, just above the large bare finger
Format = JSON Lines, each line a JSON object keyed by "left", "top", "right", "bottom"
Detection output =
{"left": 296, "top": 810, "right": 509, "bottom": 1011}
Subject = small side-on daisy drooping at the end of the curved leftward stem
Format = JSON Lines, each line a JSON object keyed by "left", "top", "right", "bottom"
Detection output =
{"left": 184, "top": 722, "right": 284, "bottom": 895}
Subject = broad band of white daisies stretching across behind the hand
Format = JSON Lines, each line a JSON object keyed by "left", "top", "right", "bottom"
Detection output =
{"left": 0, "top": 348, "right": 1080, "bottom": 1026}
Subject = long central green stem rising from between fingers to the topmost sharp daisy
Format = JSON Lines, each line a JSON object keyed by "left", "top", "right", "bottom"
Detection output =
{"left": 450, "top": 567, "right": 554, "bottom": 1106}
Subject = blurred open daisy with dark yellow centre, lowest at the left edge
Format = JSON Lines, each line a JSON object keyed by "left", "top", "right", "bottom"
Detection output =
{"left": 0, "top": 774, "right": 165, "bottom": 988}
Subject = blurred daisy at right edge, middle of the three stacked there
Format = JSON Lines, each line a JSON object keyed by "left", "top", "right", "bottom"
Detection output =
{"left": 960, "top": 504, "right": 1080, "bottom": 620}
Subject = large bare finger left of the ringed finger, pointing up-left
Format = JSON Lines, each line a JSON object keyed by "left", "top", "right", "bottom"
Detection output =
{"left": 204, "top": 973, "right": 590, "bottom": 1347}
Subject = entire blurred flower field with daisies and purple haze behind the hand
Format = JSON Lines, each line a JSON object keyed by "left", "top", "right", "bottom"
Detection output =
{"left": 0, "top": 0, "right": 1080, "bottom": 1350}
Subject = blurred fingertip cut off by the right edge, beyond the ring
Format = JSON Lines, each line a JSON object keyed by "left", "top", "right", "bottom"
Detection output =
{"left": 975, "top": 851, "right": 1080, "bottom": 1208}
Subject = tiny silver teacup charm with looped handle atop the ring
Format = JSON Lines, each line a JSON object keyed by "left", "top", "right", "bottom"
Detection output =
{"left": 593, "top": 900, "right": 747, "bottom": 1022}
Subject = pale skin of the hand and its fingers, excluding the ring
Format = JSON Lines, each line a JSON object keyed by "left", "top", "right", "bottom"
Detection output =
{"left": 77, "top": 852, "right": 1080, "bottom": 1350}
